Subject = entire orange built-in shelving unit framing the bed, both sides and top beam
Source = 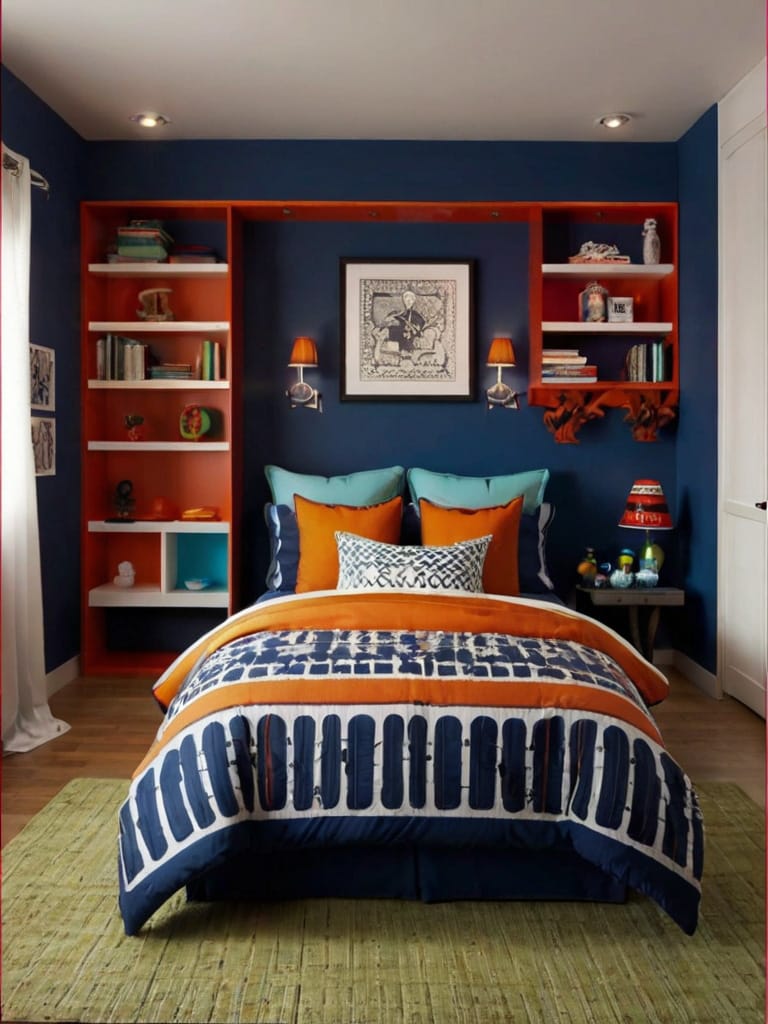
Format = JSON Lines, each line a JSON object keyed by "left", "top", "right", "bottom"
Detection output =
{"left": 81, "top": 201, "right": 679, "bottom": 676}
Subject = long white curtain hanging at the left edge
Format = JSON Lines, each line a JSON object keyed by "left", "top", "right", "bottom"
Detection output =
{"left": 0, "top": 146, "right": 70, "bottom": 754}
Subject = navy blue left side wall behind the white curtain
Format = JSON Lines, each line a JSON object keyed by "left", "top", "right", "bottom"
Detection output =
{"left": 2, "top": 68, "right": 86, "bottom": 671}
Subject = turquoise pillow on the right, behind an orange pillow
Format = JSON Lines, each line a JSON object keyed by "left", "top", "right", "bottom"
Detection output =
{"left": 408, "top": 469, "right": 549, "bottom": 515}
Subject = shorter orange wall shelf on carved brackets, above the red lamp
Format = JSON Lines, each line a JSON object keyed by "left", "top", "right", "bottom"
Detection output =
{"left": 528, "top": 203, "right": 679, "bottom": 443}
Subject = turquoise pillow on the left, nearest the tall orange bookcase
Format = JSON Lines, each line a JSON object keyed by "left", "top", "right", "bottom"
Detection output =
{"left": 264, "top": 466, "right": 406, "bottom": 509}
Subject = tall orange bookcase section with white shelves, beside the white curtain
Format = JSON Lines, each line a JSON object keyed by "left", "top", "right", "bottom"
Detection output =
{"left": 82, "top": 202, "right": 242, "bottom": 676}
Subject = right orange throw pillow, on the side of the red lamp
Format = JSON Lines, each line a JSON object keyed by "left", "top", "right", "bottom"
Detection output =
{"left": 419, "top": 496, "right": 524, "bottom": 597}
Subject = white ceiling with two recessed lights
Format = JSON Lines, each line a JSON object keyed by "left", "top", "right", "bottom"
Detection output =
{"left": 2, "top": 0, "right": 766, "bottom": 141}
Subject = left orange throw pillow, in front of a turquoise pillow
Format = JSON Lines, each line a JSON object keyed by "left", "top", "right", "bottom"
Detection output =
{"left": 294, "top": 495, "right": 402, "bottom": 594}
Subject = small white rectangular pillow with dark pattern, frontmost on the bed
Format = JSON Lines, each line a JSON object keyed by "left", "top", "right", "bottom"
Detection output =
{"left": 336, "top": 530, "right": 492, "bottom": 593}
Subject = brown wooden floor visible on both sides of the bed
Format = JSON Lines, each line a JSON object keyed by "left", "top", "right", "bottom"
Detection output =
{"left": 2, "top": 669, "right": 766, "bottom": 845}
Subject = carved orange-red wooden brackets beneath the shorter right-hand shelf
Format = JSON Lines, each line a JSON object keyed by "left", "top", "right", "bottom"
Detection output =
{"left": 544, "top": 388, "right": 678, "bottom": 444}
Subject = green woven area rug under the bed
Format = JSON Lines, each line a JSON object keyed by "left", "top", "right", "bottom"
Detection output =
{"left": 2, "top": 779, "right": 765, "bottom": 1024}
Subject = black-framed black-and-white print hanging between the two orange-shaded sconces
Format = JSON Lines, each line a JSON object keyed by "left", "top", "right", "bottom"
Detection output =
{"left": 340, "top": 259, "right": 474, "bottom": 401}
